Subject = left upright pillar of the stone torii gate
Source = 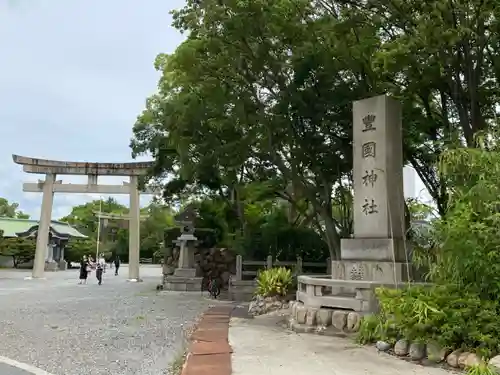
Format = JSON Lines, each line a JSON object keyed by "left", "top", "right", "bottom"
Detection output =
{"left": 32, "top": 173, "right": 56, "bottom": 278}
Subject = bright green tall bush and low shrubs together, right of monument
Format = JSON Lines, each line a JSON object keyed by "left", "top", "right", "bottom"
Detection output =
{"left": 363, "top": 132, "right": 500, "bottom": 360}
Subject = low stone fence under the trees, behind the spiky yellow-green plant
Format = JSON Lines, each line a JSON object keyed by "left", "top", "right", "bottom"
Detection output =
{"left": 234, "top": 255, "right": 332, "bottom": 280}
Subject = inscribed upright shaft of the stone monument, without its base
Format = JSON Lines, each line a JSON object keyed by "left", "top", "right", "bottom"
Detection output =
{"left": 353, "top": 95, "right": 405, "bottom": 238}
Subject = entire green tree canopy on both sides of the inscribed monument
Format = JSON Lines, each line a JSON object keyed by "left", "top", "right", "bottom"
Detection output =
{"left": 131, "top": 0, "right": 499, "bottom": 257}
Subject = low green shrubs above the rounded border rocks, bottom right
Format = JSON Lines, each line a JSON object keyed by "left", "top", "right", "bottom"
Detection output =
{"left": 376, "top": 285, "right": 500, "bottom": 357}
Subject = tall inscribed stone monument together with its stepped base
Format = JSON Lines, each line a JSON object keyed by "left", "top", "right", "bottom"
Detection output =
{"left": 332, "top": 95, "right": 410, "bottom": 283}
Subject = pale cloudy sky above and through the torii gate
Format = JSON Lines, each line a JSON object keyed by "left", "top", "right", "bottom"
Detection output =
{"left": 0, "top": 0, "right": 188, "bottom": 219}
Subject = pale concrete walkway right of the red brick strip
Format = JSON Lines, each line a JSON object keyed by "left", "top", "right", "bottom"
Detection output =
{"left": 229, "top": 315, "right": 451, "bottom": 375}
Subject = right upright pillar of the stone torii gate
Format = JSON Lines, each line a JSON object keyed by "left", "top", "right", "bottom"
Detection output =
{"left": 128, "top": 176, "right": 140, "bottom": 281}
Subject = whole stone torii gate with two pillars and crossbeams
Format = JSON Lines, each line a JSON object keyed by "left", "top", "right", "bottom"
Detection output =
{"left": 12, "top": 155, "right": 155, "bottom": 281}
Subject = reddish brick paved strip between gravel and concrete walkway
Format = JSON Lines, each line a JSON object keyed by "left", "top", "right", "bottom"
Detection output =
{"left": 181, "top": 306, "right": 234, "bottom": 375}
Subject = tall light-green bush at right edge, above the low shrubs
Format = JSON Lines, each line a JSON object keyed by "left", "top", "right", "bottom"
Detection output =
{"left": 430, "top": 133, "right": 500, "bottom": 300}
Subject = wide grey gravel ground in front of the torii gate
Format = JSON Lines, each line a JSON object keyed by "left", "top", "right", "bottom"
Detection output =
{"left": 0, "top": 267, "right": 210, "bottom": 375}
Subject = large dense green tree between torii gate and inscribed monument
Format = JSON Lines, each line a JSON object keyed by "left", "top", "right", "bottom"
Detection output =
{"left": 132, "top": 0, "right": 379, "bottom": 257}
